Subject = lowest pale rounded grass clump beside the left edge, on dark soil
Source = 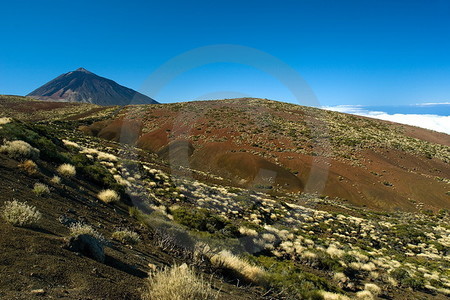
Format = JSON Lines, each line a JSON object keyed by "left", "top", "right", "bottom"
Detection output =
{"left": 1, "top": 200, "right": 42, "bottom": 227}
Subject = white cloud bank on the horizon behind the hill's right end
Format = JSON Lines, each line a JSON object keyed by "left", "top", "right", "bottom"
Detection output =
{"left": 323, "top": 103, "right": 450, "bottom": 134}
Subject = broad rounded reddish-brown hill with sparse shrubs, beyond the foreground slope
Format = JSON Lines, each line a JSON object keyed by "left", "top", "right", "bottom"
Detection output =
{"left": 79, "top": 99, "right": 450, "bottom": 211}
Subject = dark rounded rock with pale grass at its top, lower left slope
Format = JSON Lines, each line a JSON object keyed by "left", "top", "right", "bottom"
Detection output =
{"left": 66, "top": 234, "right": 105, "bottom": 263}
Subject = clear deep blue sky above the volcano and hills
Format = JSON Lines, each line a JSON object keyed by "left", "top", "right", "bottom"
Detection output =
{"left": 0, "top": 0, "right": 450, "bottom": 105}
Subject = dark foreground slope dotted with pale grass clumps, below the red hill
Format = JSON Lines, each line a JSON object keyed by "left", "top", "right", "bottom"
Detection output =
{"left": 0, "top": 116, "right": 450, "bottom": 300}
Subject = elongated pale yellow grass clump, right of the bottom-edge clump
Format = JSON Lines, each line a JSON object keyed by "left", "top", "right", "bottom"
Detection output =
{"left": 211, "top": 250, "right": 266, "bottom": 283}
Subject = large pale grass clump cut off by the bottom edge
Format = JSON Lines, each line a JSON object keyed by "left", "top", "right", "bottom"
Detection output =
{"left": 142, "top": 264, "right": 218, "bottom": 300}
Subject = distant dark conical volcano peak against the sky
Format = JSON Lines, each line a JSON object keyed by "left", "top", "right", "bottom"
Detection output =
{"left": 27, "top": 68, "right": 158, "bottom": 105}
